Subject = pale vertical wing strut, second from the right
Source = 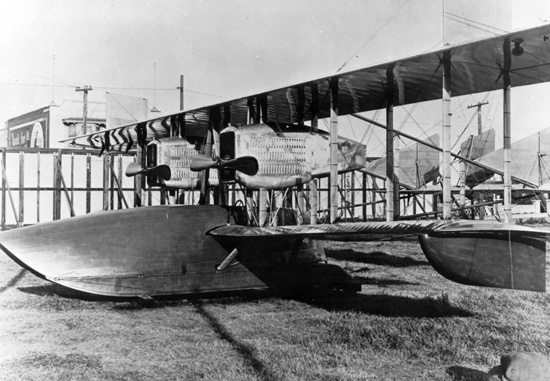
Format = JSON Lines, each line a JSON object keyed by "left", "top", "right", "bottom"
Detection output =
{"left": 442, "top": 50, "right": 451, "bottom": 220}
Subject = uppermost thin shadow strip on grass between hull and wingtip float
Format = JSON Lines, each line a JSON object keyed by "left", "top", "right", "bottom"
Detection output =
{"left": 325, "top": 249, "right": 429, "bottom": 267}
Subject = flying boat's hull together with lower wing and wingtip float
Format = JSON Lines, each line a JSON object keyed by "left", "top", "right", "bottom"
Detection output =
{"left": 0, "top": 205, "right": 547, "bottom": 298}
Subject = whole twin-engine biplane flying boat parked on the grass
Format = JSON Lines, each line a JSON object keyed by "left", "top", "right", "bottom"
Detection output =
{"left": 0, "top": 25, "right": 550, "bottom": 297}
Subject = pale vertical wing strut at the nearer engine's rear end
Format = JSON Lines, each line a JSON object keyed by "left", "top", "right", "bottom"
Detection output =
{"left": 329, "top": 77, "right": 338, "bottom": 224}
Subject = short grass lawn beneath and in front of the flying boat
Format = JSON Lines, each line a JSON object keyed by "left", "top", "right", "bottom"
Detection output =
{"left": 0, "top": 236, "right": 550, "bottom": 381}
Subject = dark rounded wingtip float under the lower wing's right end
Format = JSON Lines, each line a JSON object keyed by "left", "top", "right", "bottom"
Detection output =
{"left": 419, "top": 221, "right": 549, "bottom": 292}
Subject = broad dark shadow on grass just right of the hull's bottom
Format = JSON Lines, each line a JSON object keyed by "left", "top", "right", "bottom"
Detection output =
{"left": 296, "top": 292, "right": 474, "bottom": 318}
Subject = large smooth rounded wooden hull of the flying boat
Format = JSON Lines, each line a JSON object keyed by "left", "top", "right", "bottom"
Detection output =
{"left": 0, "top": 206, "right": 358, "bottom": 297}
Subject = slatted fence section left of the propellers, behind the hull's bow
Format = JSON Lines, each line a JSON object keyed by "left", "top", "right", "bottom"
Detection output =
{"left": 0, "top": 147, "right": 141, "bottom": 230}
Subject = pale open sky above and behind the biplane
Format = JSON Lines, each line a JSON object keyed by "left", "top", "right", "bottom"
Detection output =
{"left": 0, "top": 0, "right": 550, "bottom": 153}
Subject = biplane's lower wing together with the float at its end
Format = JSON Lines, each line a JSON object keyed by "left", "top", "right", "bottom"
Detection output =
{"left": 209, "top": 221, "right": 550, "bottom": 292}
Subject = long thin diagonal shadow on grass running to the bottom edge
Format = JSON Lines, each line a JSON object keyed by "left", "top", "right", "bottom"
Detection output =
{"left": 193, "top": 301, "right": 279, "bottom": 381}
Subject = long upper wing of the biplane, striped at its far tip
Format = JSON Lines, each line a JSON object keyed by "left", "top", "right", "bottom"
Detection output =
{"left": 61, "top": 25, "right": 550, "bottom": 149}
